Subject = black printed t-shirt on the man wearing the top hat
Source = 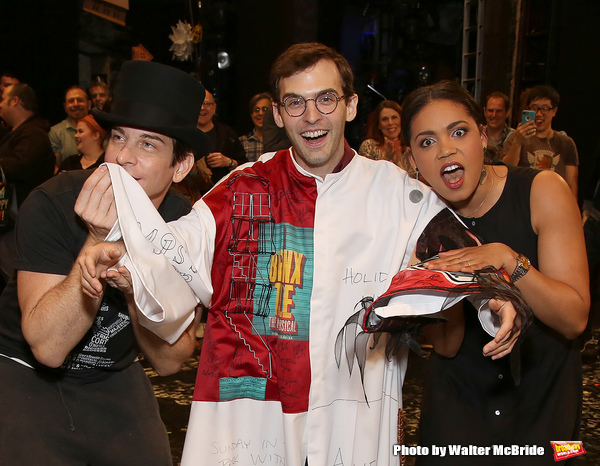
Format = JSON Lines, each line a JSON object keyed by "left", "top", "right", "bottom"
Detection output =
{"left": 0, "top": 170, "right": 190, "bottom": 383}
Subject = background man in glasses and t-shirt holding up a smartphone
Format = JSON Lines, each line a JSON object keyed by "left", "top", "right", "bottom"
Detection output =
{"left": 502, "top": 86, "right": 579, "bottom": 198}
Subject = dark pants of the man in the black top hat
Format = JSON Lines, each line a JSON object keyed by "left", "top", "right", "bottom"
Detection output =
{"left": 0, "top": 356, "right": 172, "bottom": 466}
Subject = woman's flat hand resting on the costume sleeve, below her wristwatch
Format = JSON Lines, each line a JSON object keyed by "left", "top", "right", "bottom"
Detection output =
{"left": 423, "top": 243, "right": 518, "bottom": 274}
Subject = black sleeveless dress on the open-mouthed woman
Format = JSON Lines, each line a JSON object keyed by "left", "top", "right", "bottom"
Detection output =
{"left": 416, "top": 167, "right": 583, "bottom": 466}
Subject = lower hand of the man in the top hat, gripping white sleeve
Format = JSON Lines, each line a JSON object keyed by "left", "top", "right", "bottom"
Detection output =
{"left": 77, "top": 242, "right": 125, "bottom": 298}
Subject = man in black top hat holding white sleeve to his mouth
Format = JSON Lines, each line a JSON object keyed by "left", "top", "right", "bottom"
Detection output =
{"left": 0, "top": 62, "right": 206, "bottom": 466}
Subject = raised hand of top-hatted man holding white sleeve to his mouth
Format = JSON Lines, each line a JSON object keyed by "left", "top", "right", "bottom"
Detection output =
{"left": 75, "top": 165, "right": 117, "bottom": 242}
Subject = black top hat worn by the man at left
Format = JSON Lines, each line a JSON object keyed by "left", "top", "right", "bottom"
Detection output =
{"left": 92, "top": 61, "right": 208, "bottom": 159}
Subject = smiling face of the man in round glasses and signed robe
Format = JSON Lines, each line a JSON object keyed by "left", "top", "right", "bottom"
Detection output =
{"left": 273, "top": 60, "right": 358, "bottom": 177}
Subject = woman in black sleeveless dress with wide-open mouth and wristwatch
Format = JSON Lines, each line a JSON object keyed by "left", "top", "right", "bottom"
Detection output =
{"left": 402, "top": 82, "right": 589, "bottom": 466}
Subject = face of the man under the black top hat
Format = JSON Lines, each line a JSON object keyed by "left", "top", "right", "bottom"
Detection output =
{"left": 104, "top": 126, "right": 194, "bottom": 208}
